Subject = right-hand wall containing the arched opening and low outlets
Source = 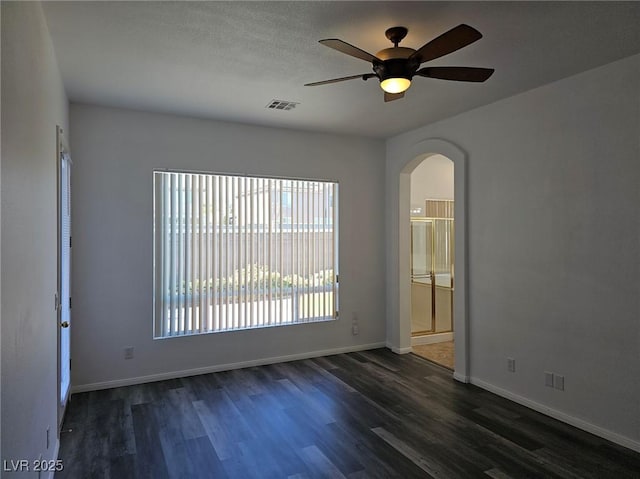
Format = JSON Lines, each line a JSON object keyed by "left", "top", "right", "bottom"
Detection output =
{"left": 387, "top": 56, "right": 640, "bottom": 449}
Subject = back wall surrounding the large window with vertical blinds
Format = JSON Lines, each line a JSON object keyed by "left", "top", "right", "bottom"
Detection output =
{"left": 70, "top": 104, "right": 385, "bottom": 390}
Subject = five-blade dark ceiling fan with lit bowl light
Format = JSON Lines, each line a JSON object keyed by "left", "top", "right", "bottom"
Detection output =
{"left": 305, "top": 24, "right": 494, "bottom": 102}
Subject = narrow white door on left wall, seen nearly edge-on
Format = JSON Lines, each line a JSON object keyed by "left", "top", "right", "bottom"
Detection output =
{"left": 57, "top": 128, "right": 71, "bottom": 429}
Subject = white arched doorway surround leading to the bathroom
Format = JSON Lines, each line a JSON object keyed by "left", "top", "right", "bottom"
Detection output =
{"left": 388, "top": 139, "right": 470, "bottom": 382}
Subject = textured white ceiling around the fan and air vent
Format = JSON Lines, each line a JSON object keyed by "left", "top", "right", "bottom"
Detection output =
{"left": 43, "top": 1, "right": 640, "bottom": 138}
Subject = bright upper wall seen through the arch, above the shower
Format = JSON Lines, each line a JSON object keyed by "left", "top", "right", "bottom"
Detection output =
{"left": 411, "top": 155, "right": 453, "bottom": 211}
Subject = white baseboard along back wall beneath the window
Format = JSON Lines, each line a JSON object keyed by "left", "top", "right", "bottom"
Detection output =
{"left": 71, "top": 343, "right": 386, "bottom": 393}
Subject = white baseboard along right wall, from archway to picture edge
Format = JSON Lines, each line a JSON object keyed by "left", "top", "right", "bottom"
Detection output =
{"left": 470, "top": 374, "right": 640, "bottom": 452}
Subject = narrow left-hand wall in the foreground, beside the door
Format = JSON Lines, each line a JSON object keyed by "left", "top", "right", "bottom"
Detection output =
{"left": 1, "top": 2, "right": 68, "bottom": 477}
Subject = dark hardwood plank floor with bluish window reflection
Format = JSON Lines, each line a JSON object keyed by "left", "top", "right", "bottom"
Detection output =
{"left": 56, "top": 349, "right": 640, "bottom": 479}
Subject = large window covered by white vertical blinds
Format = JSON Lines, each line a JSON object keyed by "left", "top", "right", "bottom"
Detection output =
{"left": 153, "top": 171, "right": 338, "bottom": 338}
